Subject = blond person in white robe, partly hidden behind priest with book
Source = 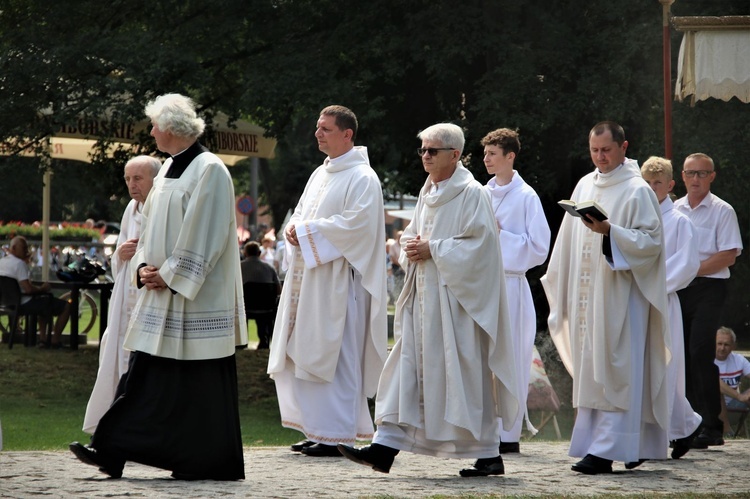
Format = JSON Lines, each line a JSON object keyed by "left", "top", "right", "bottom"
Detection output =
{"left": 641, "top": 156, "right": 702, "bottom": 459}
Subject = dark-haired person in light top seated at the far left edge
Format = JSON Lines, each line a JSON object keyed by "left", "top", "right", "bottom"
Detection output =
{"left": 0, "top": 236, "right": 70, "bottom": 348}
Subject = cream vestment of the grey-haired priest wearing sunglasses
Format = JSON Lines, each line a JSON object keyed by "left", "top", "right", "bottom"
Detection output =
{"left": 374, "top": 163, "right": 519, "bottom": 458}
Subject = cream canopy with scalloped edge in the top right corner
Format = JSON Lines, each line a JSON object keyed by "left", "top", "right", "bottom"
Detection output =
{"left": 674, "top": 16, "right": 750, "bottom": 104}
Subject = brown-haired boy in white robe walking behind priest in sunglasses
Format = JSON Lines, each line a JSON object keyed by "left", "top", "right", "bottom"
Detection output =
{"left": 482, "top": 128, "right": 550, "bottom": 454}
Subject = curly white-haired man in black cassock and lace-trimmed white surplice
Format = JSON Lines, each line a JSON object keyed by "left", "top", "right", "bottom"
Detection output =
{"left": 70, "top": 94, "right": 247, "bottom": 480}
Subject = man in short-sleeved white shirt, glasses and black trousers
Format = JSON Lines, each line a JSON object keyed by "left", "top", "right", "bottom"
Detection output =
{"left": 675, "top": 153, "right": 742, "bottom": 449}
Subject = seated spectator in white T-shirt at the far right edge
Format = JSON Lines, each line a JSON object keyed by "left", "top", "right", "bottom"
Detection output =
{"left": 714, "top": 327, "right": 750, "bottom": 409}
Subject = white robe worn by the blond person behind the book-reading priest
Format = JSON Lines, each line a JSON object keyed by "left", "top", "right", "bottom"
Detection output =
{"left": 661, "top": 196, "right": 702, "bottom": 440}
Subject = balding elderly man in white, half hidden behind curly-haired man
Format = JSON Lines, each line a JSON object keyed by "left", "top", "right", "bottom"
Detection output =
{"left": 83, "top": 156, "right": 161, "bottom": 434}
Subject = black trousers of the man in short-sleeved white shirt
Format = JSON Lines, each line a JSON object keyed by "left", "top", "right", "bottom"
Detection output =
{"left": 677, "top": 277, "right": 727, "bottom": 431}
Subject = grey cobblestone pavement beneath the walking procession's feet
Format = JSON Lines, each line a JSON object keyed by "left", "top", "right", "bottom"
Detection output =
{"left": 0, "top": 440, "right": 750, "bottom": 499}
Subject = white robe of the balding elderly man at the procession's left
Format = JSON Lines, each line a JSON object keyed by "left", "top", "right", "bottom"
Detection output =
{"left": 83, "top": 199, "right": 143, "bottom": 435}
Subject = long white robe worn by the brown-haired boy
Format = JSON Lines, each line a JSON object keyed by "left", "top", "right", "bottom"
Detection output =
{"left": 486, "top": 170, "right": 550, "bottom": 442}
